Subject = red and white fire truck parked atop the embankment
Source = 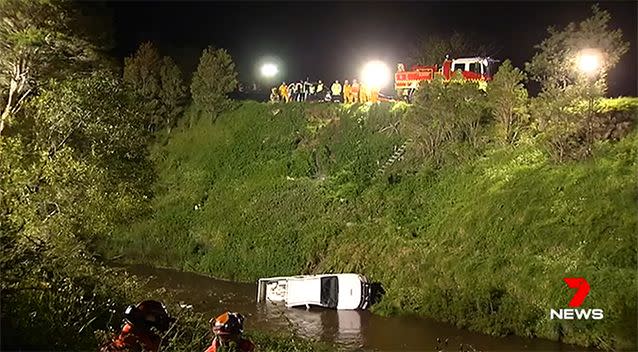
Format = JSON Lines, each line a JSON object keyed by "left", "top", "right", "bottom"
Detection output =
{"left": 394, "top": 57, "right": 499, "bottom": 102}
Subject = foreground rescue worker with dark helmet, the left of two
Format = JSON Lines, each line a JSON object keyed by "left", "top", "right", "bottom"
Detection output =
{"left": 100, "top": 300, "right": 175, "bottom": 352}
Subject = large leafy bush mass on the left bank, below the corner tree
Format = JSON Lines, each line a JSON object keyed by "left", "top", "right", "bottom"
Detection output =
{"left": 0, "top": 72, "right": 153, "bottom": 350}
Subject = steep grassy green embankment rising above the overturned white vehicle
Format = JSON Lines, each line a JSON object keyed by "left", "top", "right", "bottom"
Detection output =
{"left": 102, "top": 103, "right": 638, "bottom": 349}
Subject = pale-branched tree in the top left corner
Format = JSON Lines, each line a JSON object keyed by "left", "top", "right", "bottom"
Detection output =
{"left": 0, "top": 0, "right": 110, "bottom": 135}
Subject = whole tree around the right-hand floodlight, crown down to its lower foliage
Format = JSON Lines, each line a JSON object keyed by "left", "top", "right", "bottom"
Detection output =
{"left": 525, "top": 5, "right": 629, "bottom": 161}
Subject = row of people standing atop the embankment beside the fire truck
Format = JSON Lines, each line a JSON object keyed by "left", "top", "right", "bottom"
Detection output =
{"left": 270, "top": 78, "right": 379, "bottom": 104}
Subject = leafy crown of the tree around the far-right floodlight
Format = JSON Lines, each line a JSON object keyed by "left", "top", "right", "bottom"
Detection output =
{"left": 525, "top": 5, "right": 629, "bottom": 96}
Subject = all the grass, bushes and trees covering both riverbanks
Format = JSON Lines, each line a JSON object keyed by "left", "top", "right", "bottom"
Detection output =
{"left": 0, "top": 0, "right": 638, "bottom": 351}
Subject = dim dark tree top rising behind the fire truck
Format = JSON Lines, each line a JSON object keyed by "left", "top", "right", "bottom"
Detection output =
{"left": 412, "top": 32, "right": 495, "bottom": 65}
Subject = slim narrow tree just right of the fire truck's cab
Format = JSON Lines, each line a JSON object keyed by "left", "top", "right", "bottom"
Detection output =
{"left": 487, "top": 60, "right": 527, "bottom": 143}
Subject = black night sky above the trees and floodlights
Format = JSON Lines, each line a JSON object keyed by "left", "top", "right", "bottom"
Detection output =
{"left": 108, "top": 1, "right": 638, "bottom": 96}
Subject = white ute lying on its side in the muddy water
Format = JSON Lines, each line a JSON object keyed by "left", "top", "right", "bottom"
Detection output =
{"left": 257, "top": 274, "right": 370, "bottom": 310}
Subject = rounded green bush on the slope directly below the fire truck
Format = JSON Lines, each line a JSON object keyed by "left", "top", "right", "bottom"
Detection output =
{"left": 404, "top": 77, "right": 485, "bottom": 163}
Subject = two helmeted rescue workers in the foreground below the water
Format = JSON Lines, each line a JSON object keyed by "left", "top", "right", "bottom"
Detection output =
{"left": 100, "top": 300, "right": 255, "bottom": 352}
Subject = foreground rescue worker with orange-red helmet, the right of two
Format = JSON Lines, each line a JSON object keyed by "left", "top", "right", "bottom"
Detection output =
{"left": 204, "top": 312, "right": 255, "bottom": 352}
